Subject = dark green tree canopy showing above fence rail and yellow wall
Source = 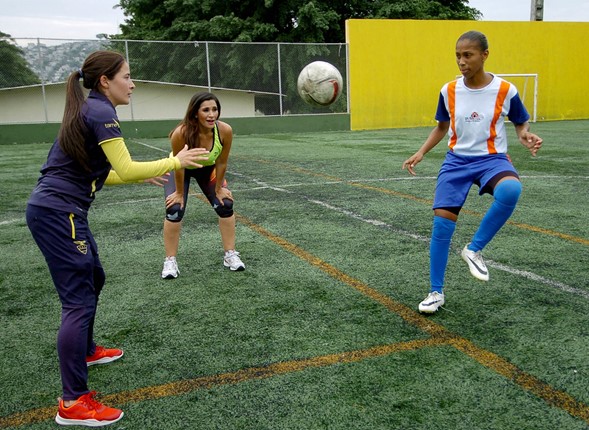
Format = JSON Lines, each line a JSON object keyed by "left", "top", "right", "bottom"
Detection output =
{"left": 120, "top": 0, "right": 481, "bottom": 43}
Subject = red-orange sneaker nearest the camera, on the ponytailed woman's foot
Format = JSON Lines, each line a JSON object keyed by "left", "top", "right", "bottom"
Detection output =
{"left": 55, "top": 391, "right": 123, "bottom": 427}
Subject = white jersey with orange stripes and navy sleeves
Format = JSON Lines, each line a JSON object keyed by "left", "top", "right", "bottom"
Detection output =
{"left": 436, "top": 76, "right": 530, "bottom": 156}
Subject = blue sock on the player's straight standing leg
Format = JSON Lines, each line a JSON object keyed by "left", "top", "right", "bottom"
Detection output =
{"left": 429, "top": 216, "right": 456, "bottom": 293}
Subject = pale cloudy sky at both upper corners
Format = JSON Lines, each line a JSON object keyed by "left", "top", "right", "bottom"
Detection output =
{"left": 0, "top": 0, "right": 589, "bottom": 39}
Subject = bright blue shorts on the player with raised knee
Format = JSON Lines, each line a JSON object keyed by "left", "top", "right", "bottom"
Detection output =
{"left": 433, "top": 151, "right": 519, "bottom": 209}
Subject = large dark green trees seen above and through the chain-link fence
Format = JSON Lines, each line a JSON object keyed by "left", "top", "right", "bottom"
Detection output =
{"left": 111, "top": 0, "right": 480, "bottom": 114}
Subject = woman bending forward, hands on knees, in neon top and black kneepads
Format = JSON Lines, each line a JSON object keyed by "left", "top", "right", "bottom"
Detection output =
{"left": 162, "top": 92, "right": 245, "bottom": 279}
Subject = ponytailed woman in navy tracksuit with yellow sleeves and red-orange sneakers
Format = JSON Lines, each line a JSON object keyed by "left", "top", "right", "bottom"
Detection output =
{"left": 26, "top": 51, "right": 208, "bottom": 426}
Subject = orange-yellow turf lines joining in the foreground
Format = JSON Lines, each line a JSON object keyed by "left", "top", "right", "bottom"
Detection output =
{"left": 0, "top": 202, "right": 589, "bottom": 428}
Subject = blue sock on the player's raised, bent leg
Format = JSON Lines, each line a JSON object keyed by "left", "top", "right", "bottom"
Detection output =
{"left": 468, "top": 179, "right": 522, "bottom": 252}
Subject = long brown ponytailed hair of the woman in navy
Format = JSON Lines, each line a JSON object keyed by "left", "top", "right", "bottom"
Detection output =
{"left": 58, "top": 51, "right": 125, "bottom": 171}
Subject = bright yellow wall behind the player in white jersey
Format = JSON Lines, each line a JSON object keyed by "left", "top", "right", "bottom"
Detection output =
{"left": 346, "top": 19, "right": 589, "bottom": 130}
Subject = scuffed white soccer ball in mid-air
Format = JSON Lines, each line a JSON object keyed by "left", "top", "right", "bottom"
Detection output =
{"left": 297, "top": 61, "right": 343, "bottom": 106}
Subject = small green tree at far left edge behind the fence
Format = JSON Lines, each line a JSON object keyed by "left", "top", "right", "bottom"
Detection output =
{"left": 0, "top": 31, "right": 41, "bottom": 88}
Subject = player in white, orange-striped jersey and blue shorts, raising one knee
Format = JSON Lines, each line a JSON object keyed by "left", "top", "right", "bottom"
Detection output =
{"left": 403, "top": 31, "right": 542, "bottom": 313}
